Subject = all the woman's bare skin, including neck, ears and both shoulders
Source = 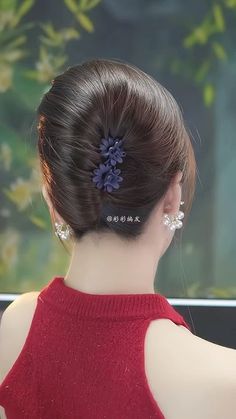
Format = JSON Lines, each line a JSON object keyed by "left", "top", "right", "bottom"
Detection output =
{"left": 0, "top": 172, "right": 236, "bottom": 419}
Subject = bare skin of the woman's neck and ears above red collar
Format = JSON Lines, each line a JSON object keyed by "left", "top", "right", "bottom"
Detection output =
{"left": 43, "top": 172, "right": 182, "bottom": 294}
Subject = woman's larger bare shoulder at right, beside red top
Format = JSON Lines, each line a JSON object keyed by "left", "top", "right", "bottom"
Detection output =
{"left": 145, "top": 319, "right": 236, "bottom": 419}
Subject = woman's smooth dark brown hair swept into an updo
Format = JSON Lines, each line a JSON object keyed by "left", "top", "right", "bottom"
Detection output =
{"left": 37, "top": 59, "right": 196, "bottom": 243}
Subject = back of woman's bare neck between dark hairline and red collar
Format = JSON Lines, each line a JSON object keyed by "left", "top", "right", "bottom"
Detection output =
{"left": 64, "top": 234, "right": 159, "bottom": 294}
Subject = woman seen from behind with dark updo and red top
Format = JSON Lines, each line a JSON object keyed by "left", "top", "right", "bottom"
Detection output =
{"left": 0, "top": 59, "right": 236, "bottom": 419}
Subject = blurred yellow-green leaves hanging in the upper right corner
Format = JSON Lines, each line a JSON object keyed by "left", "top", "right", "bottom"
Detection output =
{"left": 169, "top": 0, "right": 236, "bottom": 107}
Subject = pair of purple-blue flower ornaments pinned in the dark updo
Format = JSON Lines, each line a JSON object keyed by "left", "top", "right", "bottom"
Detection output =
{"left": 92, "top": 136, "right": 126, "bottom": 192}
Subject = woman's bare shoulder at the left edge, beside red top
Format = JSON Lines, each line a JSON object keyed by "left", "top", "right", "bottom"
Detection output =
{"left": 0, "top": 291, "right": 39, "bottom": 383}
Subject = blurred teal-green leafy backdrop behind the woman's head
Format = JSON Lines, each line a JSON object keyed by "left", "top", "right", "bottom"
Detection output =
{"left": 0, "top": 0, "right": 236, "bottom": 299}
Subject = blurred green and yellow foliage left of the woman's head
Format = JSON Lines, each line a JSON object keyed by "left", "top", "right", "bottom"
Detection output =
{"left": 0, "top": 0, "right": 100, "bottom": 292}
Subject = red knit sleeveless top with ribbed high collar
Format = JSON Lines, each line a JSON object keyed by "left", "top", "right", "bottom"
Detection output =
{"left": 0, "top": 276, "right": 191, "bottom": 419}
